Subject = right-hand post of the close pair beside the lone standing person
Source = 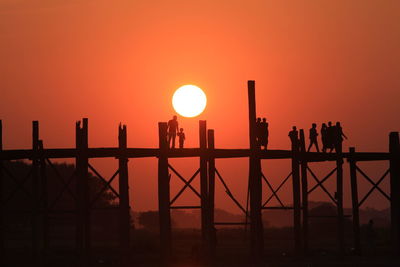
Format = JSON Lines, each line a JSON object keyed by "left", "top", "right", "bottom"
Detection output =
{"left": 300, "top": 129, "right": 308, "bottom": 254}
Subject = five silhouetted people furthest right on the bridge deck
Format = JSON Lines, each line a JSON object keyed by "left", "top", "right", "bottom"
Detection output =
{"left": 289, "top": 121, "right": 347, "bottom": 153}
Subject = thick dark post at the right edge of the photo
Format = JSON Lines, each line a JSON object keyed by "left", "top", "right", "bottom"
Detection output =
{"left": 389, "top": 132, "right": 400, "bottom": 254}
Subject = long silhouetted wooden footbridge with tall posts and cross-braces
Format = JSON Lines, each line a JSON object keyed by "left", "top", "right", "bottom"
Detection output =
{"left": 0, "top": 81, "right": 400, "bottom": 262}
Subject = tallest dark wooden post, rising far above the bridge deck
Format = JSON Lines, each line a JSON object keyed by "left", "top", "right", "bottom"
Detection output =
{"left": 247, "top": 81, "right": 264, "bottom": 260}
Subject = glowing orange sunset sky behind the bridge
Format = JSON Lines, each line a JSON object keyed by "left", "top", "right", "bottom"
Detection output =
{"left": 0, "top": 0, "right": 400, "bottom": 214}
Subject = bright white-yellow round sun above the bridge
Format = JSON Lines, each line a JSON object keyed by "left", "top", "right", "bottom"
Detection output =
{"left": 172, "top": 84, "right": 207, "bottom": 118}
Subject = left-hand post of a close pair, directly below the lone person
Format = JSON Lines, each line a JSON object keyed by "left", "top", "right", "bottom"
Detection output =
{"left": 292, "top": 129, "right": 302, "bottom": 255}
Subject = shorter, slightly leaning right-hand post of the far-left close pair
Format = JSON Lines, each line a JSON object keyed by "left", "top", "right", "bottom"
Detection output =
{"left": 39, "top": 140, "right": 49, "bottom": 256}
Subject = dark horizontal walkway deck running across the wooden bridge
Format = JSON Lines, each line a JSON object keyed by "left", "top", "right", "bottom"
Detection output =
{"left": 0, "top": 148, "right": 390, "bottom": 162}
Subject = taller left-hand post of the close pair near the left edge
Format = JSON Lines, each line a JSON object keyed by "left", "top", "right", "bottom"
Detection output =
{"left": 31, "top": 121, "right": 39, "bottom": 261}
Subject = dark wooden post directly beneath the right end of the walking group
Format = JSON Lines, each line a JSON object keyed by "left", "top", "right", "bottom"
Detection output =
{"left": 335, "top": 142, "right": 344, "bottom": 255}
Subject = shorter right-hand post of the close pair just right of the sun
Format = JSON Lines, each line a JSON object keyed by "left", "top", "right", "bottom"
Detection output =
{"left": 207, "top": 130, "right": 217, "bottom": 257}
